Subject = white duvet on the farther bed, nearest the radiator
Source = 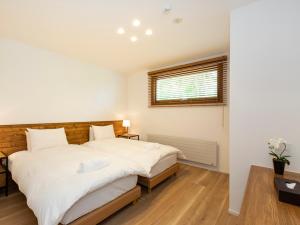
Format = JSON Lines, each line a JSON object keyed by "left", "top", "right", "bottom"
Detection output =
{"left": 84, "top": 138, "right": 185, "bottom": 177}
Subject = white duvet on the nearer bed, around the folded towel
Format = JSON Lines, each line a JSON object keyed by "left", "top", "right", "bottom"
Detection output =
{"left": 9, "top": 145, "right": 140, "bottom": 225}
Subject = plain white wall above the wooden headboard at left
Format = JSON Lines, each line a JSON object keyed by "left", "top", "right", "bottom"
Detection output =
{"left": 0, "top": 39, "right": 127, "bottom": 124}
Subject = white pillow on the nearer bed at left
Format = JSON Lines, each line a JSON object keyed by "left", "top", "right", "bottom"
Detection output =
{"left": 27, "top": 128, "right": 68, "bottom": 151}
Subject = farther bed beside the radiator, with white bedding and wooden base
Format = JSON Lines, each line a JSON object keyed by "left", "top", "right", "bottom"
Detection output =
{"left": 84, "top": 126, "right": 184, "bottom": 192}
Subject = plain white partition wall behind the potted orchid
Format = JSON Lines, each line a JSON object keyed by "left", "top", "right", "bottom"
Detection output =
{"left": 230, "top": 0, "right": 300, "bottom": 212}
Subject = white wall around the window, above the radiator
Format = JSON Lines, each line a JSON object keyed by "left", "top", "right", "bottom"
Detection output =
{"left": 128, "top": 71, "right": 228, "bottom": 172}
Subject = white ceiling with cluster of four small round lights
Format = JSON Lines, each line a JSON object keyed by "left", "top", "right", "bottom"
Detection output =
{"left": 0, "top": 0, "right": 254, "bottom": 74}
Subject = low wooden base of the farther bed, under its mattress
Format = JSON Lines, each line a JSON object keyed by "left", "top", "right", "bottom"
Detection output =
{"left": 138, "top": 163, "right": 179, "bottom": 193}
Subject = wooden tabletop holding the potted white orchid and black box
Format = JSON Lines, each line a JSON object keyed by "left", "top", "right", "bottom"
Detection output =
{"left": 239, "top": 166, "right": 300, "bottom": 225}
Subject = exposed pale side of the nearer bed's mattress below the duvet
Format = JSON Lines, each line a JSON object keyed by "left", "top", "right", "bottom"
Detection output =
{"left": 61, "top": 175, "right": 137, "bottom": 224}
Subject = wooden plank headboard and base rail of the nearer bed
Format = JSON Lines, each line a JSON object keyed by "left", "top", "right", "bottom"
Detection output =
{"left": 0, "top": 120, "right": 141, "bottom": 225}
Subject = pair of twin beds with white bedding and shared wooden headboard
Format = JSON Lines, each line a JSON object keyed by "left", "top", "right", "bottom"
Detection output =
{"left": 0, "top": 121, "right": 183, "bottom": 225}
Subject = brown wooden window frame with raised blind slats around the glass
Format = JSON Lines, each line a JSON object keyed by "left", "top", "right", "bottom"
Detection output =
{"left": 148, "top": 56, "right": 227, "bottom": 107}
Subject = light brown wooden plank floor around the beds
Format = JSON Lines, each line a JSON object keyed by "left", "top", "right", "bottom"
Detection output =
{"left": 0, "top": 165, "right": 238, "bottom": 225}
